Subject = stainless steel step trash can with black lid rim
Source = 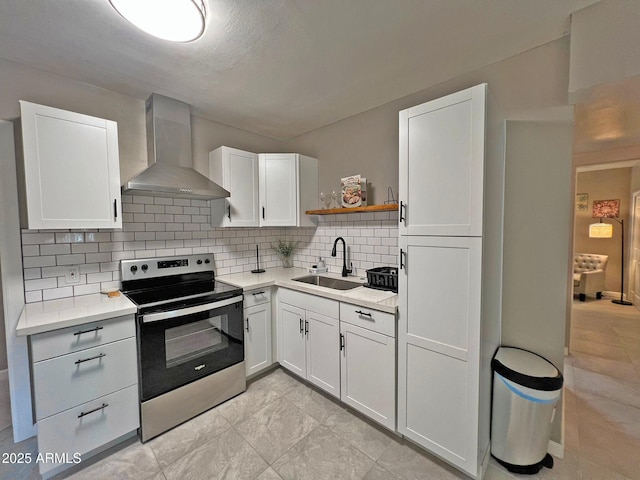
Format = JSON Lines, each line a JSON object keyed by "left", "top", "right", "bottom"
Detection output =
{"left": 491, "top": 347, "right": 563, "bottom": 474}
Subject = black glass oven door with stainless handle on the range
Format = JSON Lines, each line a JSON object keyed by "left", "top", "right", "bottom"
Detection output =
{"left": 137, "top": 296, "right": 244, "bottom": 401}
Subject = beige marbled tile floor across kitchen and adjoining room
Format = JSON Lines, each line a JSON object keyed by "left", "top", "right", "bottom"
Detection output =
{"left": 0, "top": 299, "right": 640, "bottom": 480}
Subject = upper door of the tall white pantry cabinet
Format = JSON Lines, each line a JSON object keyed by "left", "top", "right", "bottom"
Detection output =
{"left": 399, "top": 85, "right": 486, "bottom": 236}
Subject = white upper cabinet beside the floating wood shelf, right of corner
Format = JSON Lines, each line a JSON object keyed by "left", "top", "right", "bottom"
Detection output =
{"left": 260, "top": 153, "right": 318, "bottom": 227}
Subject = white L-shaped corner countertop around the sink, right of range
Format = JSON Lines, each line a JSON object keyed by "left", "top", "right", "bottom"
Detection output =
{"left": 222, "top": 267, "right": 398, "bottom": 314}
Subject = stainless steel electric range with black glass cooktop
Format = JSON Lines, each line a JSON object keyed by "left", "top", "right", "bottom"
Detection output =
{"left": 120, "top": 254, "right": 246, "bottom": 442}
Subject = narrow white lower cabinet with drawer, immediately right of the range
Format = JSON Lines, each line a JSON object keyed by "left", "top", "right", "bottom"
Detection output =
{"left": 244, "top": 288, "right": 273, "bottom": 376}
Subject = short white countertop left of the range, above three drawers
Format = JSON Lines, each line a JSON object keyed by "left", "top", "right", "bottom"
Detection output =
{"left": 16, "top": 293, "right": 137, "bottom": 336}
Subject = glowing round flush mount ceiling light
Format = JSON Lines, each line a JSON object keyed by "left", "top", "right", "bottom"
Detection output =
{"left": 109, "top": 0, "right": 206, "bottom": 42}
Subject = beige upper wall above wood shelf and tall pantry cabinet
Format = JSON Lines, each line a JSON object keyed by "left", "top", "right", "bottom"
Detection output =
{"left": 286, "top": 38, "right": 573, "bottom": 204}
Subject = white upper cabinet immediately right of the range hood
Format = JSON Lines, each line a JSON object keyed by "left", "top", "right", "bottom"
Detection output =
{"left": 209, "top": 147, "right": 260, "bottom": 227}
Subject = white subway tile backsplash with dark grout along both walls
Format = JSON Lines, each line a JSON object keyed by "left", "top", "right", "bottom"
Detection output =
{"left": 22, "top": 195, "right": 398, "bottom": 302}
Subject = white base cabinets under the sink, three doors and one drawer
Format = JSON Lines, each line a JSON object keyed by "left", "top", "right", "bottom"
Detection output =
{"left": 278, "top": 289, "right": 396, "bottom": 430}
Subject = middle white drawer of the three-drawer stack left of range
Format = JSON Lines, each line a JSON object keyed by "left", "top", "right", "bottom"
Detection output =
{"left": 33, "top": 338, "right": 138, "bottom": 420}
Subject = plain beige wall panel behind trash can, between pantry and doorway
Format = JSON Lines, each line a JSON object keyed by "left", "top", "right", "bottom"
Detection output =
{"left": 502, "top": 121, "right": 573, "bottom": 443}
